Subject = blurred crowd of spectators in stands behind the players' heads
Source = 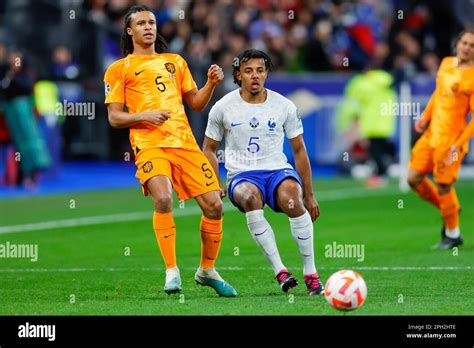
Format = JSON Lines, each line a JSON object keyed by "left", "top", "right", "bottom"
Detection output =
{"left": 88, "top": 0, "right": 474, "bottom": 73}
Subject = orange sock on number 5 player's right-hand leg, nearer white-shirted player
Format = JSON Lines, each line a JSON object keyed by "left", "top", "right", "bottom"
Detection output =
{"left": 200, "top": 216, "right": 222, "bottom": 269}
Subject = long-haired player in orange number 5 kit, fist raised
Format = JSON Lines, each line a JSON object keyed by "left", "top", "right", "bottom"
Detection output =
{"left": 104, "top": 6, "right": 237, "bottom": 297}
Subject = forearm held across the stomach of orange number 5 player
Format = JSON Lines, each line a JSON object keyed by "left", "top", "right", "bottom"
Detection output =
{"left": 107, "top": 103, "right": 171, "bottom": 128}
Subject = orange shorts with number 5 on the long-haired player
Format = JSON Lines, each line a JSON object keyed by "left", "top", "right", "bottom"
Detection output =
{"left": 135, "top": 147, "right": 220, "bottom": 201}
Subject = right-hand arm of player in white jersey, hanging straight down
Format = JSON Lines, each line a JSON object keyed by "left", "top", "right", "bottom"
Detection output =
{"left": 290, "top": 134, "right": 320, "bottom": 221}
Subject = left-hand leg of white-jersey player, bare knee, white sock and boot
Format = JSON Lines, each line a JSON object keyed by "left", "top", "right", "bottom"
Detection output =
{"left": 229, "top": 181, "right": 292, "bottom": 292}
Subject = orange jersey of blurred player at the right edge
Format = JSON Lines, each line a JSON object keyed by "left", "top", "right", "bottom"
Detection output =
{"left": 424, "top": 57, "right": 474, "bottom": 147}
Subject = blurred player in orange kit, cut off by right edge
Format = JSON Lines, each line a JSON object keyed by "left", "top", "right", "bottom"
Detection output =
{"left": 408, "top": 31, "right": 474, "bottom": 249}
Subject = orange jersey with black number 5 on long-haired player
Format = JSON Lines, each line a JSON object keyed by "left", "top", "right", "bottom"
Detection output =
{"left": 104, "top": 53, "right": 199, "bottom": 149}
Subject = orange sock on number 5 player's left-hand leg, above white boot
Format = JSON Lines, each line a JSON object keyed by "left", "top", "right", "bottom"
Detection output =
{"left": 153, "top": 211, "right": 176, "bottom": 269}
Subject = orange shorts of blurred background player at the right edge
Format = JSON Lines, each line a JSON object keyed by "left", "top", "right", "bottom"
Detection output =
{"left": 410, "top": 136, "right": 466, "bottom": 184}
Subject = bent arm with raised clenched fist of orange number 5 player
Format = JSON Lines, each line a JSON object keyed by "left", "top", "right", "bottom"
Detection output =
{"left": 183, "top": 64, "right": 224, "bottom": 112}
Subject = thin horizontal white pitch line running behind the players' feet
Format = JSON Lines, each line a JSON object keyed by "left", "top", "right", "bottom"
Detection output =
{"left": 0, "top": 266, "right": 474, "bottom": 273}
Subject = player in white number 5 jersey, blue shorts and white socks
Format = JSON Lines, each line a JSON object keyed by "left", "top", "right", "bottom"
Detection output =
{"left": 203, "top": 49, "right": 324, "bottom": 295}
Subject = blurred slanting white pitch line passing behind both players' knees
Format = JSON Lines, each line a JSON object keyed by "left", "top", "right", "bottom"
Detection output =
{"left": 0, "top": 188, "right": 402, "bottom": 234}
